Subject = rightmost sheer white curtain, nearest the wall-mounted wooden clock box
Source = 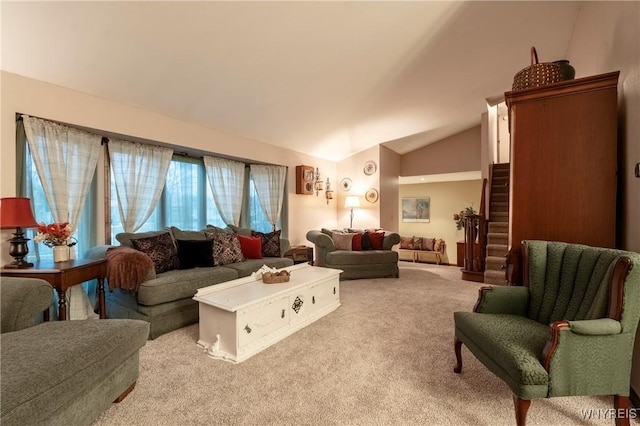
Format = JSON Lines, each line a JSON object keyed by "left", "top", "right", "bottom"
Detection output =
{"left": 251, "top": 164, "right": 287, "bottom": 231}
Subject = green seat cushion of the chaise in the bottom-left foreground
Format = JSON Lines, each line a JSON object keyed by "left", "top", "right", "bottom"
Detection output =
{"left": 0, "top": 319, "right": 149, "bottom": 424}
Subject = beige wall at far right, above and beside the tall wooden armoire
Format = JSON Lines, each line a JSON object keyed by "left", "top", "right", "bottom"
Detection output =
{"left": 567, "top": 2, "right": 640, "bottom": 400}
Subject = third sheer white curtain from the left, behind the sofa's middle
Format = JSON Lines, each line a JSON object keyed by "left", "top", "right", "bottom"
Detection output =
{"left": 204, "top": 156, "right": 244, "bottom": 226}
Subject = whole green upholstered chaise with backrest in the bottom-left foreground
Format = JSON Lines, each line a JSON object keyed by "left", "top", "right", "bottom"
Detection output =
{"left": 0, "top": 277, "right": 149, "bottom": 426}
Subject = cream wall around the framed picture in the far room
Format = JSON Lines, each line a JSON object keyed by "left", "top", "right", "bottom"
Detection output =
{"left": 398, "top": 180, "right": 482, "bottom": 265}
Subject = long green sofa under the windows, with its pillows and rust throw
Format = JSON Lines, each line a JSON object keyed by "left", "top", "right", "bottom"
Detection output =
{"left": 87, "top": 226, "right": 293, "bottom": 339}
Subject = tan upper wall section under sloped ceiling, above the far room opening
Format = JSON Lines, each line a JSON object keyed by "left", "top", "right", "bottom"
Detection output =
{"left": 401, "top": 125, "right": 480, "bottom": 176}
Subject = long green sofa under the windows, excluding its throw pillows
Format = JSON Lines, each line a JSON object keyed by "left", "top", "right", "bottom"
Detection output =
{"left": 87, "top": 226, "right": 293, "bottom": 339}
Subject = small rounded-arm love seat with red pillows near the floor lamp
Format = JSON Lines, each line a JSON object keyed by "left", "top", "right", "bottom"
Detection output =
{"left": 307, "top": 228, "right": 400, "bottom": 280}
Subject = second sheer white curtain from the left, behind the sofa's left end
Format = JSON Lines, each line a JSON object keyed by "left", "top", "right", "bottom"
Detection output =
{"left": 108, "top": 139, "right": 173, "bottom": 232}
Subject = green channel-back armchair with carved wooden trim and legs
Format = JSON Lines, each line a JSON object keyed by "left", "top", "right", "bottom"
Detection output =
{"left": 454, "top": 241, "right": 640, "bottom": 425}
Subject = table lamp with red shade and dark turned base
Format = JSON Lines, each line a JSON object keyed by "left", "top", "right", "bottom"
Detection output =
{"left": 0, "top": 197, "right": 38, "bottom": 268}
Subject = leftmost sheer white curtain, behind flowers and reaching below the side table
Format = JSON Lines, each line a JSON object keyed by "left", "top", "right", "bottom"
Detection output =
{"left": 22, "top": 115, "right": 102, "bottom": 319}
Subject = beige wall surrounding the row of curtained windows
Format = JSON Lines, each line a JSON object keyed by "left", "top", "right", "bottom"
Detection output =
{"left": 0, "top": 71, "right": 337, "bottom": 264}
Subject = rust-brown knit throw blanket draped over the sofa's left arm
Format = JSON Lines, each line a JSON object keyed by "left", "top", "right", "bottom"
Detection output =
{"left": 105, "top": 246, "right": 155, "bottom": 292}
